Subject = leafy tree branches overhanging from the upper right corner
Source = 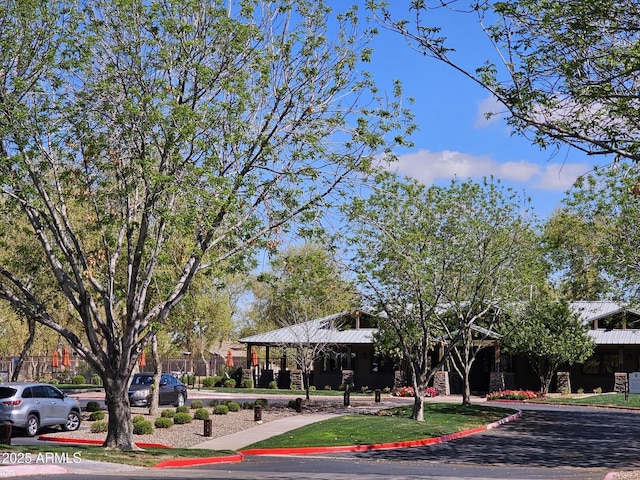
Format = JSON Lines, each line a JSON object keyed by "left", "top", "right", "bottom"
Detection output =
{"left": 367, "top": 0, "right": 640, "bottom": 161}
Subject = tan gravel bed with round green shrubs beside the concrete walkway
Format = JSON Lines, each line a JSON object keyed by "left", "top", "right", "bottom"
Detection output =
{"left": 40, "top": 401, "right": 370, "bottom": 448}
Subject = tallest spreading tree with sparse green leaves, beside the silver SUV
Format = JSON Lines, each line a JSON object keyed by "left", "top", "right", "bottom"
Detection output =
{"left": 0, "top": 0, "right": 406, "bottom": 449}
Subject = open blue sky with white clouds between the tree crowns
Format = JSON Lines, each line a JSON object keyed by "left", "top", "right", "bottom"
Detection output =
{"left": 350, "top": 0, "right": 593, "bottom": 218}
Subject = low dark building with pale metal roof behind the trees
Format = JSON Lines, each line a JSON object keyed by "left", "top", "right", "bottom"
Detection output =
{"left": 240, "top": 301, "right": 640, "bottom": 392}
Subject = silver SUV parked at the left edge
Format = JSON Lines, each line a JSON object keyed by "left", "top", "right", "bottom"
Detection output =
{"left": 0, "top": 382, "right": 80, "bottom": 437}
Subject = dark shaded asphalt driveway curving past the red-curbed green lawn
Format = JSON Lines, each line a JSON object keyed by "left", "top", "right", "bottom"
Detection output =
{"left": 350, "top": 404, "right": 640, "bottom": 470}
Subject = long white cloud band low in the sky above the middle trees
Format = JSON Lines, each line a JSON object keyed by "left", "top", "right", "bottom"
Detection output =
{"left": 389, "top": 150, "right": 589, "bottom": 191}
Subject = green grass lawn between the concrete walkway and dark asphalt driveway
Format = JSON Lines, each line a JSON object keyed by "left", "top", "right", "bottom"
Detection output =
{"left": 246, "top": 403, "right": 513, "bottom": 450}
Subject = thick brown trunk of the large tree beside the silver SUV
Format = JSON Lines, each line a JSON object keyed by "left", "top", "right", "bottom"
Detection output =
{"left": 102, "top": 374, "right": 137, "bottom": 450}
